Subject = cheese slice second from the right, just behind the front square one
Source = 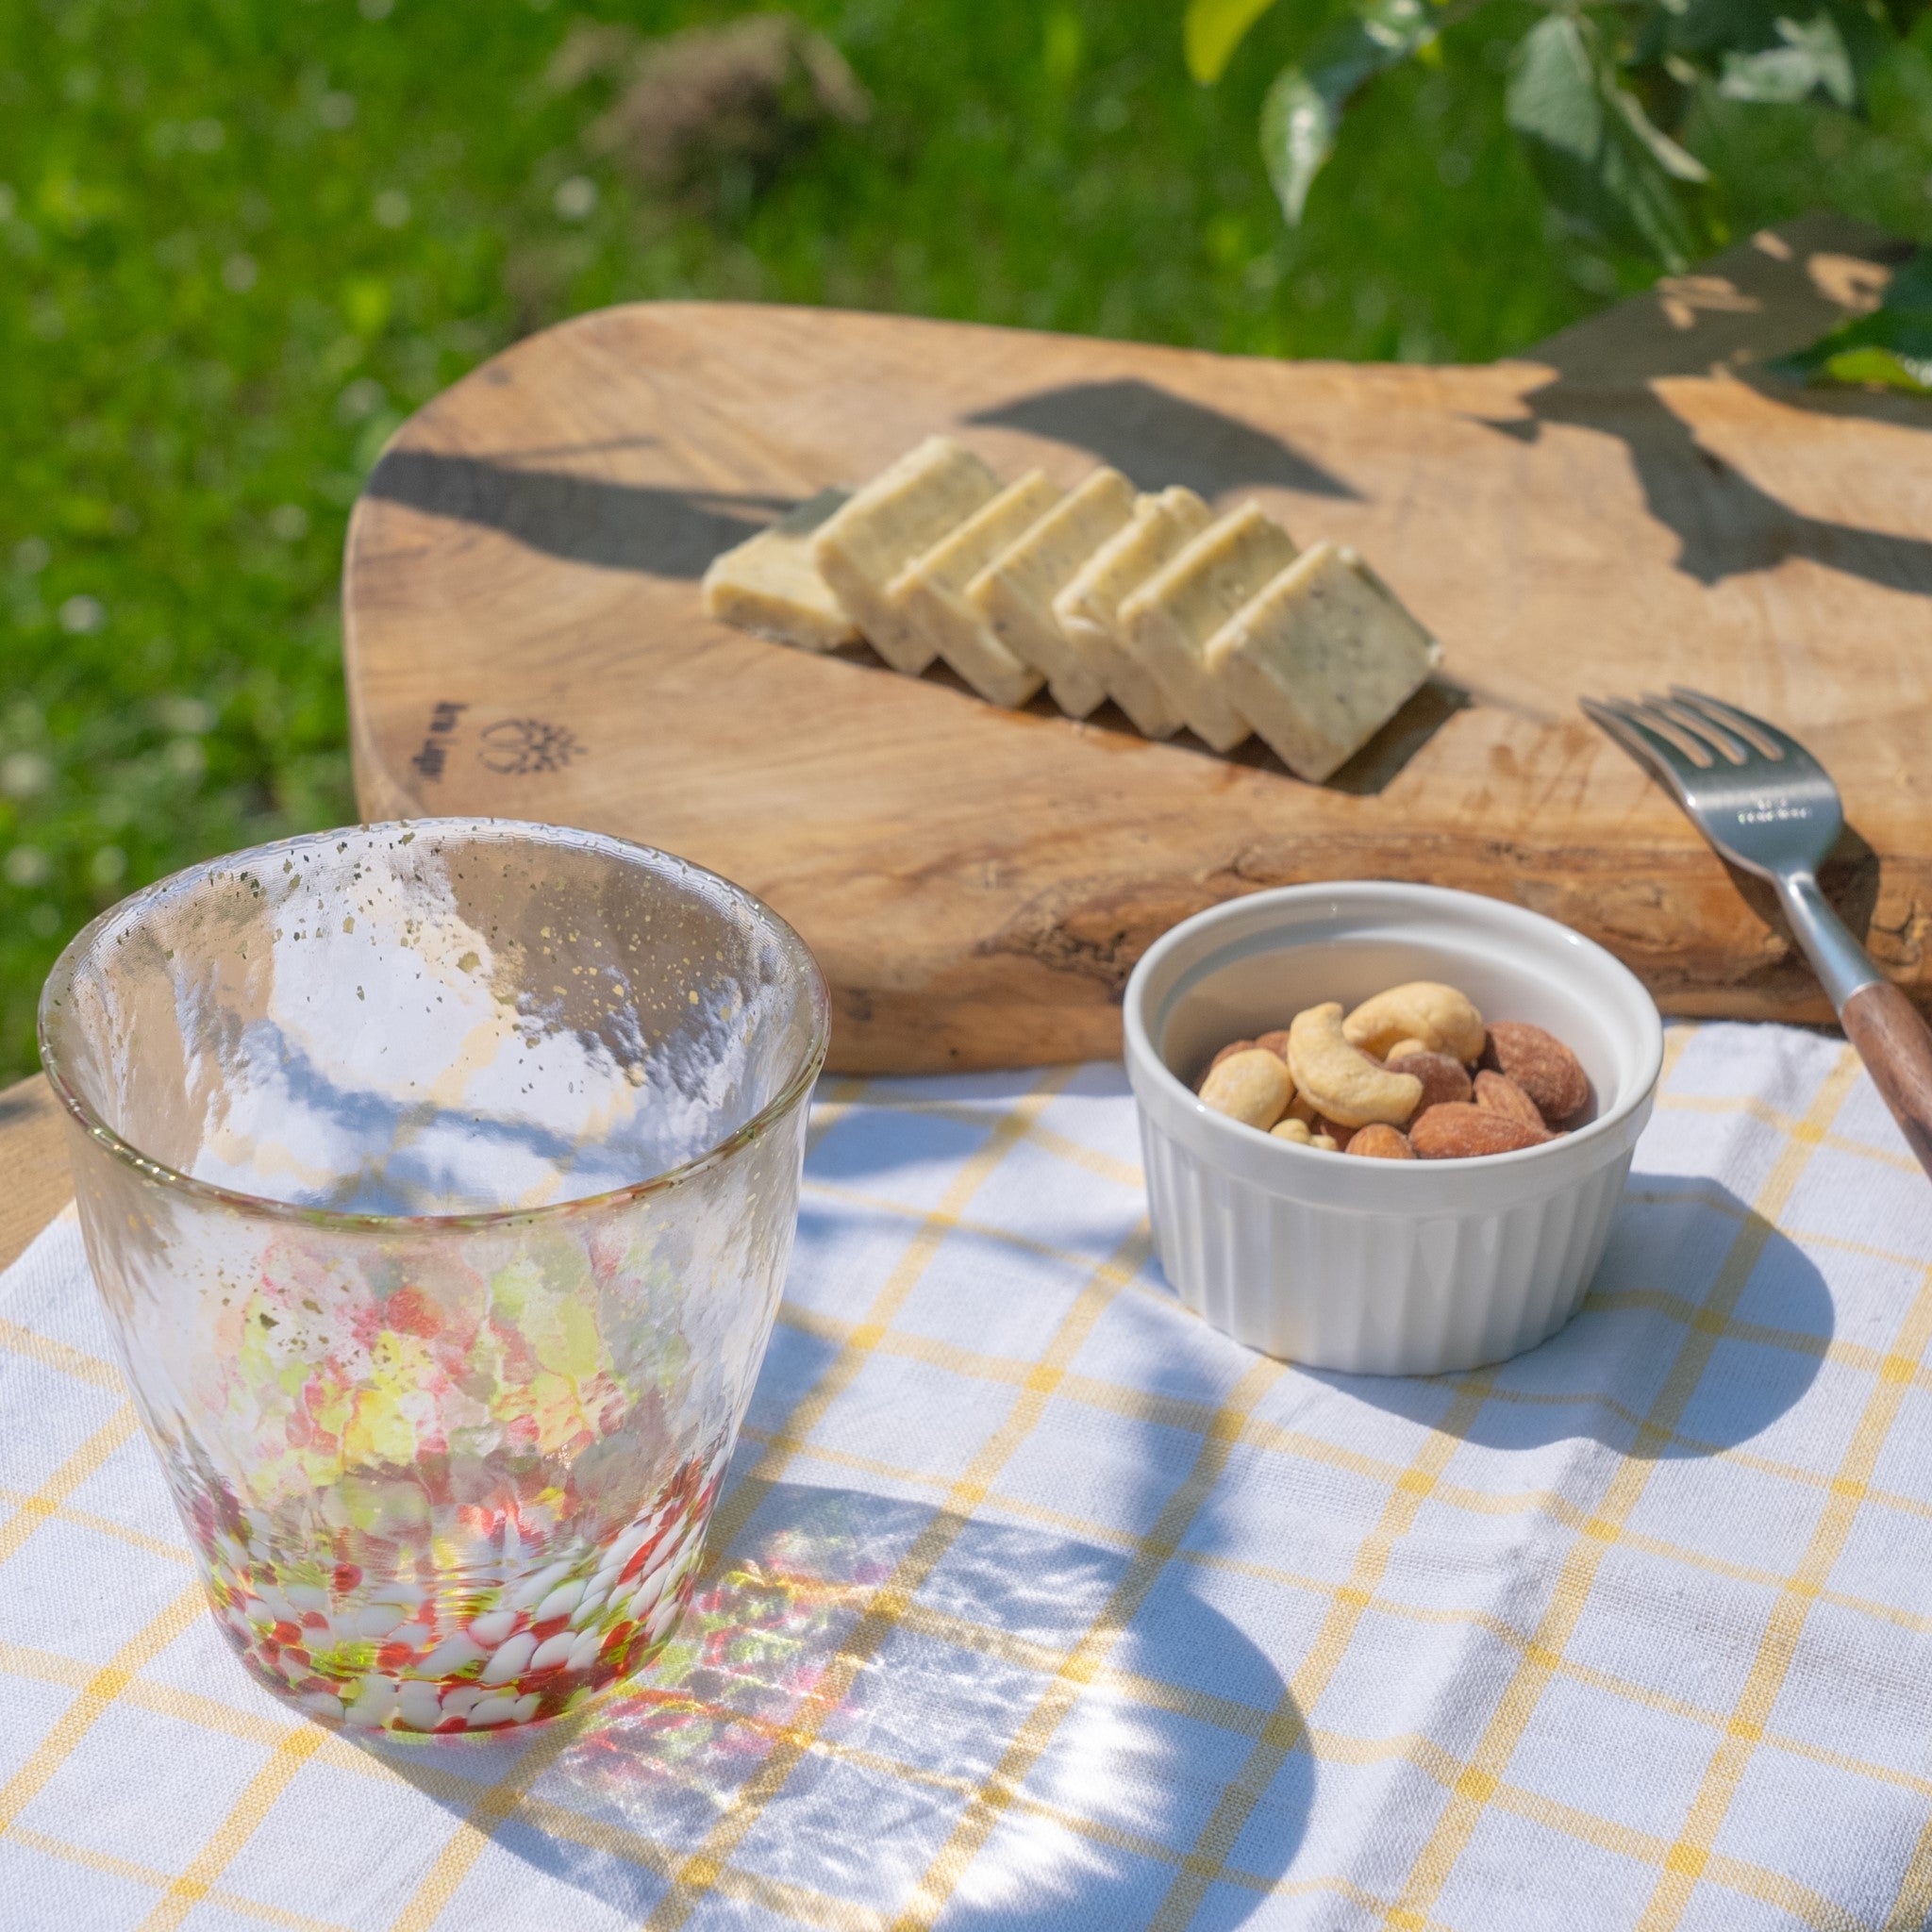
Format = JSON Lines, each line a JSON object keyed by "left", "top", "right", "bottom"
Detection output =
{"left": 1121, "top": 502, "right": 1296, "bottom": 752}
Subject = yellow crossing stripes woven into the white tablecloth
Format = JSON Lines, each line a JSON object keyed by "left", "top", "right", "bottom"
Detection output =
{"left": 0, "top": 1030, "right": 1932, "bottom": 1932}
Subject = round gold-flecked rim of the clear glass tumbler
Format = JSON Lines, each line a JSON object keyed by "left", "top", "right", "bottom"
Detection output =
{"left": 35, "top": 817, "right": 831, "bottom": 1233}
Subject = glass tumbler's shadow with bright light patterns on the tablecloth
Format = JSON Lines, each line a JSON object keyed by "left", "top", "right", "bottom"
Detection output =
{"left": 361, "top": 1475, "right": 1314, "bottom": 1932}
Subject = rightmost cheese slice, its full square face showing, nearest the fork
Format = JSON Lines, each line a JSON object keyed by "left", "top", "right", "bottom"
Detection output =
{"left": 1206, "top": 542, "right": 1441, "bottom": 784}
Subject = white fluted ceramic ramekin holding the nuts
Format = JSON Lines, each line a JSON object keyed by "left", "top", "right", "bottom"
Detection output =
{"left": 1126, "top": 881, "right": 1663, "bottom": 1375}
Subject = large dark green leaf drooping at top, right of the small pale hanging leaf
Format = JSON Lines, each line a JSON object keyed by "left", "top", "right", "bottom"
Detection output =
{"left": 1505, "top": 13, "right": 1706, "bottom": 269}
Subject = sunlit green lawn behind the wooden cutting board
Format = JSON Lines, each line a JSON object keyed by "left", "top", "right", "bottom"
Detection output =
{"left": 11, "top": 0, "right": 1932, "bottom": 1080}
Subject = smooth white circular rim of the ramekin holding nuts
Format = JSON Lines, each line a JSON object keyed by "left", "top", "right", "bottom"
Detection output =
{"left": 1121, "top": 879, "right": 1663, "bottom": 1182}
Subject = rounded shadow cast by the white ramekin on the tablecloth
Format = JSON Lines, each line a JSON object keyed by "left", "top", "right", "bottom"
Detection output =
{"left": 1320, "top": 1173, "right": 1836, "bottom": 1462}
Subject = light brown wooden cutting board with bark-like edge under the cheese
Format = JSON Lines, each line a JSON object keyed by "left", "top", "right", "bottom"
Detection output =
{"left": 344, "top": 220, "right": 1932, "bottom": 1071}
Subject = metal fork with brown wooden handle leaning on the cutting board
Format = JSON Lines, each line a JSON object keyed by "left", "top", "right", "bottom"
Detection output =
{"left": 1580, "top": 684, "right": 1932, "bottom": 1173}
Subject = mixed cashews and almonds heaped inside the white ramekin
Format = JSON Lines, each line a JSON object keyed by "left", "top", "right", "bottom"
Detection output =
{"left": 1200, "top": 979, "right": 1591, "bottom": 1161}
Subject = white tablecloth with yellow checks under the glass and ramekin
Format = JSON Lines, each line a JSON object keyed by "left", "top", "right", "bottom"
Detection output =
{"left": 0, "top": 1025, "right": 1932, "bottom": 1932}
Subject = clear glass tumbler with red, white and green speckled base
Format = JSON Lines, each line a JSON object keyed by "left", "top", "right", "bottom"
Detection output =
{"left": 41, "top": 819, "right": 829, "bottom": 1733}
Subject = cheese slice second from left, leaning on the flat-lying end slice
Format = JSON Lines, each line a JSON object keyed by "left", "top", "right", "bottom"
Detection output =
{"left": 813, "top": 437, "right": 999, "bottom": 675}
